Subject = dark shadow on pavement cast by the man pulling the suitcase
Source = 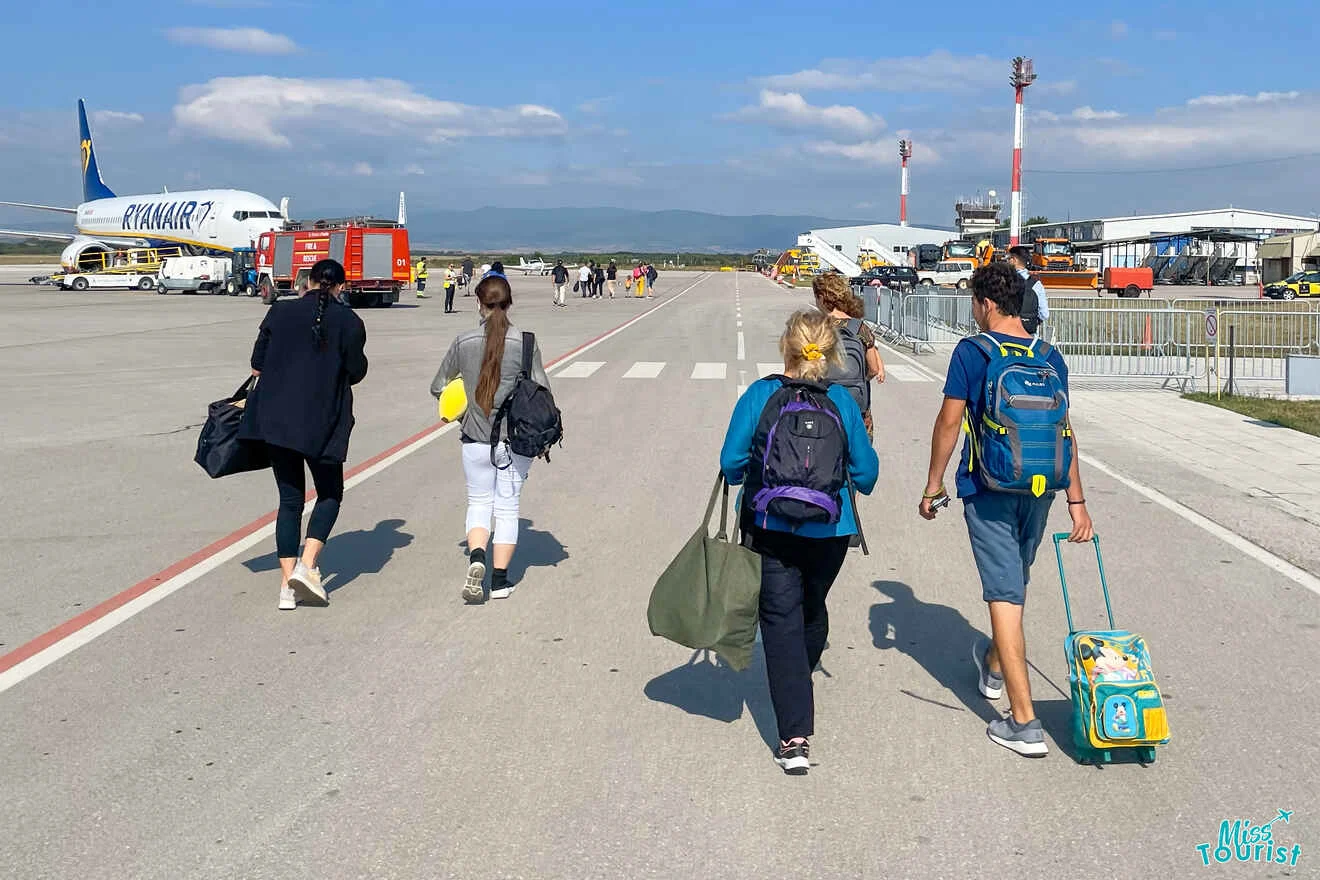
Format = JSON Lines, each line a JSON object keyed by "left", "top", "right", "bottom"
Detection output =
{"left": 871, "top": 581, "right": 1002, "bottom": 723}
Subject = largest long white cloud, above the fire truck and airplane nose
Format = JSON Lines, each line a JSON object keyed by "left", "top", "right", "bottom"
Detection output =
{"left": 174, "top": 77, "right": 565, "bottom": 149}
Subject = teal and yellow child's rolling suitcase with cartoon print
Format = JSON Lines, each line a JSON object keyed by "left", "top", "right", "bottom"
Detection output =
{"left": 1055, "top": 532, "right": 1168, "bottom": 764}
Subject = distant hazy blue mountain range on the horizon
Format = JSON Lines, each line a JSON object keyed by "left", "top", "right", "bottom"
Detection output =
{"left": 408, "top": 207, "right": 866, "bottom": 253}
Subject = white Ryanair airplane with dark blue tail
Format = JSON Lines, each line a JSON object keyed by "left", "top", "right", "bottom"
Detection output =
{"left": 0, "top": 99, "right": 285, "bottom": 269}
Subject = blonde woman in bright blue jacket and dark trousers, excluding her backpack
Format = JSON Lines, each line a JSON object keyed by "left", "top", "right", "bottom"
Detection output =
{"left": 719, "top": 310, "right": 879, "bottom": 776}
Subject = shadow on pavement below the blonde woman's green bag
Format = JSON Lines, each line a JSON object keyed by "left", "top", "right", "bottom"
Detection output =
{"left": 643, "top": 645, "right": 779, "bottom": 749}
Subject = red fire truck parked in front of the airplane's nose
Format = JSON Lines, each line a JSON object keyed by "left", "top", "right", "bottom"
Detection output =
{"left": 256, "top": 218, "right": 412, "bottom": 309}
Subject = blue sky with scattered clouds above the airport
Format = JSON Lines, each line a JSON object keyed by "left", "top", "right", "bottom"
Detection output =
{"left": 0, "top": 0, "right": 1320, "bottom": 224}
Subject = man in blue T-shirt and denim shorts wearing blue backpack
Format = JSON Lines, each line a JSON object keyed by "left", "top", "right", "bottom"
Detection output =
{"left": 920, "top": 263, "right": 1092, "bottom": 757}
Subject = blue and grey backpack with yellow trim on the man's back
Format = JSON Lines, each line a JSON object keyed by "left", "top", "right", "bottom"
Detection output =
{"left": 962, "top": 334, "right": 1073, "bottom": 497}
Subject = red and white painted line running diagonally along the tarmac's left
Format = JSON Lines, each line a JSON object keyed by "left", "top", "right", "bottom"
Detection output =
{"left": 0, "top": 273, "right": 710, "bottom": 694}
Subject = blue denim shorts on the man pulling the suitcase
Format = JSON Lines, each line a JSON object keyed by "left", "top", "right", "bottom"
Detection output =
{"left": 962, "top": 491, "right": 1055, "bottom": 606}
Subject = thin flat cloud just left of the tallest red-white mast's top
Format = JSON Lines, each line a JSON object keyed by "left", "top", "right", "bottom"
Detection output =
{"left": 755, "top": 49, "right": 1008, "bottom": 92}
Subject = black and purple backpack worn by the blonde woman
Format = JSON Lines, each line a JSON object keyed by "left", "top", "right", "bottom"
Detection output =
{"left": 747, "top": 376, "right": 847, "bottom": 528}
